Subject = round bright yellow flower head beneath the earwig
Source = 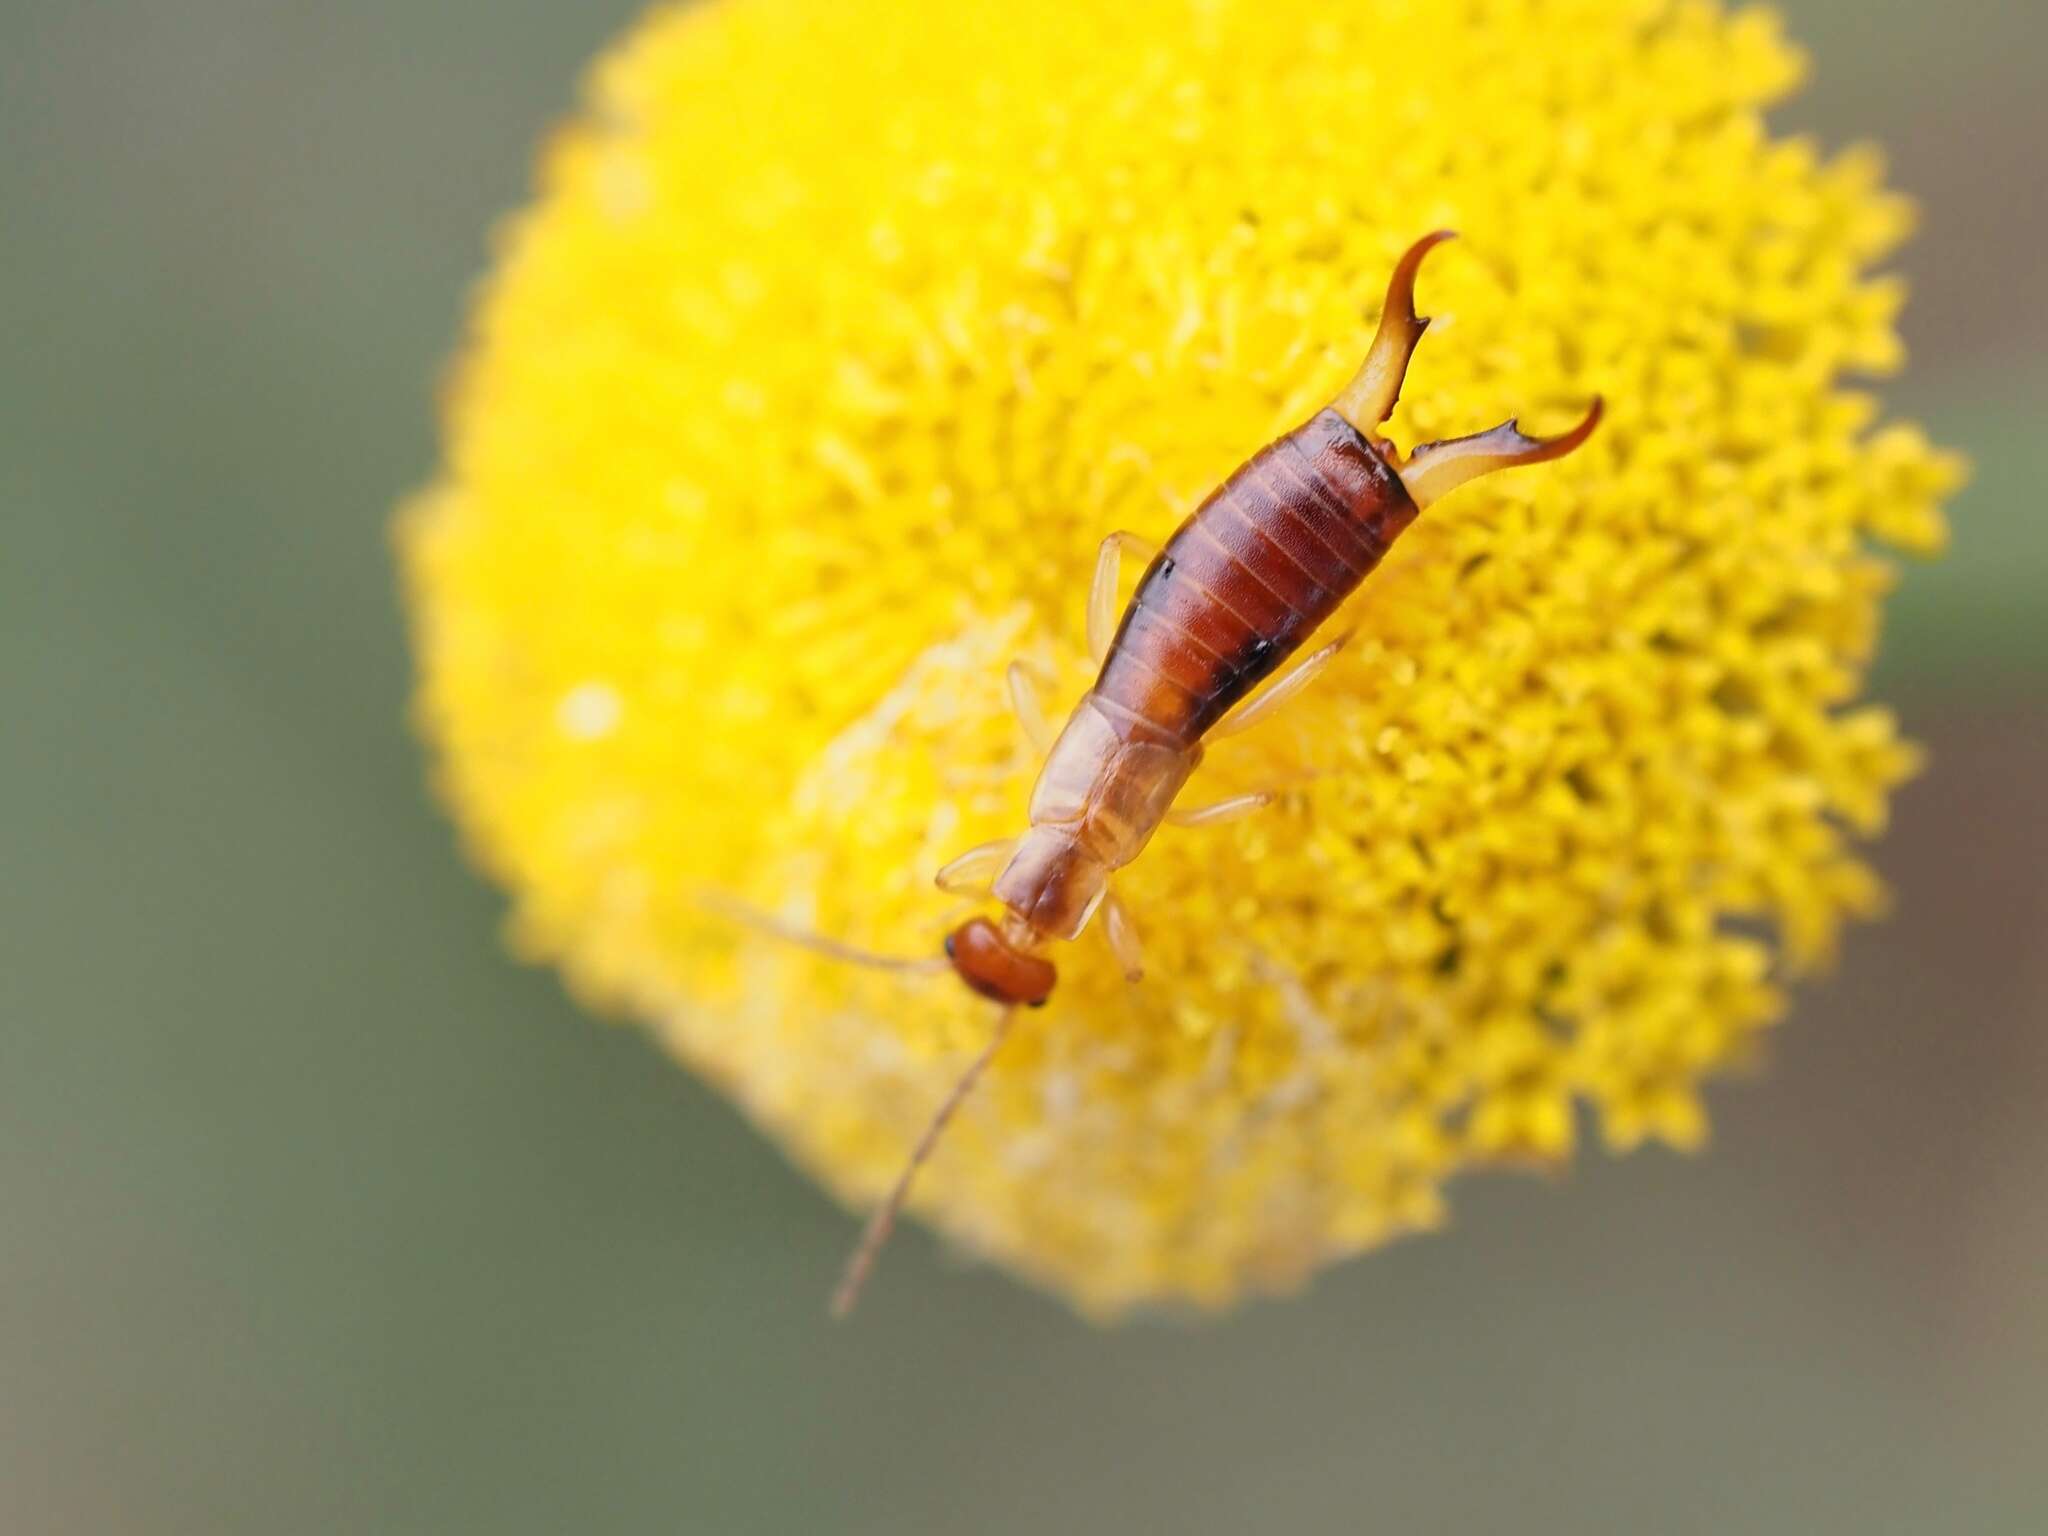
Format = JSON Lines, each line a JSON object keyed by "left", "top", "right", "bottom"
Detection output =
{"left": 403, "top": 0, "right": 1956, "bottom": 1311}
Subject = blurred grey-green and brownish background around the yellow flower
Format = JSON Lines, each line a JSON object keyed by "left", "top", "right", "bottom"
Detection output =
{"left": 0, "top": 0, "right": 2048, "bottom": 1534}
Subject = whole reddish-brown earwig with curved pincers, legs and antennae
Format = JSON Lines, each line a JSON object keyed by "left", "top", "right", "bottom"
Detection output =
{"left": 727, "top": 229, "right": 1602, "bottom": 1317}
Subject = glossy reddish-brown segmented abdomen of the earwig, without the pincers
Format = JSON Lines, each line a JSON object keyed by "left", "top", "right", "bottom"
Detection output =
{"left": 1094, "top": 410, "right": 1415, "bottom": 748}
